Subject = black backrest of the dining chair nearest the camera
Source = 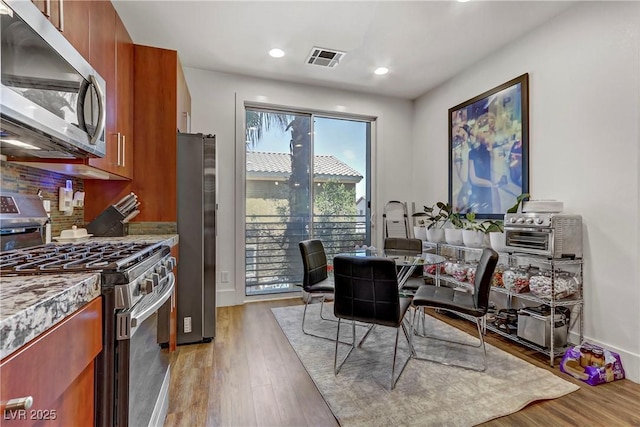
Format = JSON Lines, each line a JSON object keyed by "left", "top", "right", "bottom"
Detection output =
{"left": 333, "top": 255, "right": 400, "bottom": 327}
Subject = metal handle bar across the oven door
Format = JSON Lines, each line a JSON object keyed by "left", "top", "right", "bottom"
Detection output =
{"left": 116, "top": 273, "right": 176, "bottom": 341}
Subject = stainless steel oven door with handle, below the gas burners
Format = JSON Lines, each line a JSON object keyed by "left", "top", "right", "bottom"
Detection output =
{"left": 115, "top": 273, "right": 175, "bottom": 426}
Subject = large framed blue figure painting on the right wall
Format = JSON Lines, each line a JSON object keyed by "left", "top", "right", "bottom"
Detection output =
{"left": 449, "top": 73, "right": 529, "bottom": 219}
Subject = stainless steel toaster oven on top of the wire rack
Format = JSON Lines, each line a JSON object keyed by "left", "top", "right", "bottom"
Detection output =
{"left": 504, "top": 212, "right": 582, "bottom": 258}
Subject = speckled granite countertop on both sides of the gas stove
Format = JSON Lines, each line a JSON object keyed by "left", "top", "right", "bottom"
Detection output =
{"left": 0, "top": 234, "right": 178, "bottom": 359}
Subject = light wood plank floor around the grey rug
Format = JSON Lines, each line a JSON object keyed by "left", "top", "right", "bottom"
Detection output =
{"left": 165, "top": 299, "right": 640, "bottom": 427}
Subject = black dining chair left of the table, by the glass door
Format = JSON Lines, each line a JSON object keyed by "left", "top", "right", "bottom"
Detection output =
{"left": 298, "top": 239, "right": 334, "bottom": 340}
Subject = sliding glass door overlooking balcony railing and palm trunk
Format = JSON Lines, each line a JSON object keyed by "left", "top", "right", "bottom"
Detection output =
{"left": 245, "top": 108, "right": 371, "bottom": 295}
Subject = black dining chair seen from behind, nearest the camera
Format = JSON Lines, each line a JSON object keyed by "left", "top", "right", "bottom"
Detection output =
{"left": 333, "top": 255, "right": 413, "bottom": 389}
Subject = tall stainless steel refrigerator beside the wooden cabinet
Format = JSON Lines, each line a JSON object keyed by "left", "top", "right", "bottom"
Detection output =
{"left": 176, "top": 133, "right": 217, "bottom": 344}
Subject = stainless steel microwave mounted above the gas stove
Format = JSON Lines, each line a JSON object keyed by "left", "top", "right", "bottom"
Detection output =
{"left": 0, "top": 0, "right": 106, "bottom": 158}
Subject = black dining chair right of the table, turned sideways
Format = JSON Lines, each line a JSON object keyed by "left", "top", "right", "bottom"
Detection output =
{"left": 411, "top": 248, "right": 498, "bottom": 372}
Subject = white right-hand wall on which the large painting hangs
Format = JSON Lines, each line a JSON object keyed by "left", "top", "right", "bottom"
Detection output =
{"left": 413, "top": 2, "right": 640, "bottom": 382}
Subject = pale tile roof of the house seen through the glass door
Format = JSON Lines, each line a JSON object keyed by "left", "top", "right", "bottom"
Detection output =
{"left": 247, "top": 151, "right": 362, "bottom": 182}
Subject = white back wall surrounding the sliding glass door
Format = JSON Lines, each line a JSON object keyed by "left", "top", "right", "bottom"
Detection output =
{"left": 185, "top": 68, "right": 413, "bottom": 306}
